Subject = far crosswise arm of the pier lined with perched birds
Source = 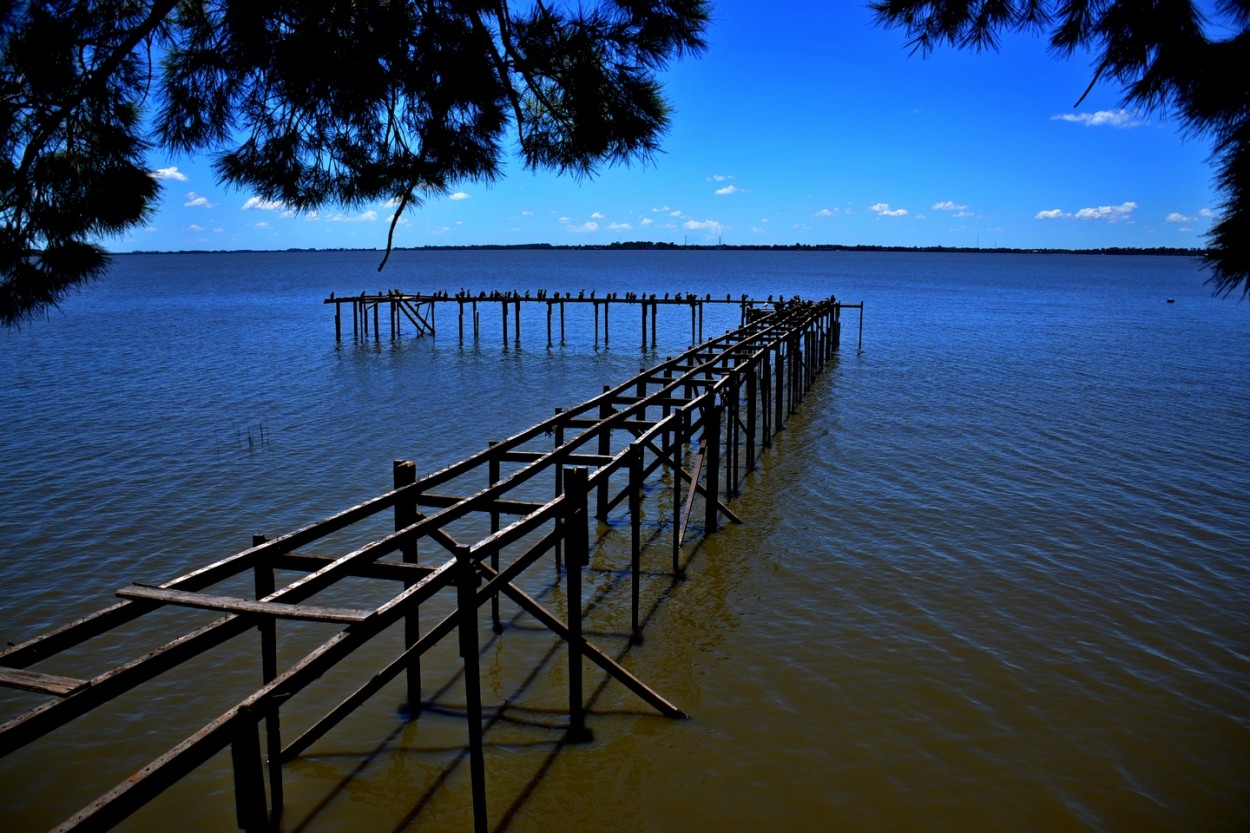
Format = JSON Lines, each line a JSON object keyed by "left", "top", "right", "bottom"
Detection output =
{"left": 324, "top": 289, "right": 820, "bottom": 348}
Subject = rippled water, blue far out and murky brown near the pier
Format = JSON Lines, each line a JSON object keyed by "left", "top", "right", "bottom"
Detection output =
{"left": 0, "top": 251, "right": 1250, "bottom": 832}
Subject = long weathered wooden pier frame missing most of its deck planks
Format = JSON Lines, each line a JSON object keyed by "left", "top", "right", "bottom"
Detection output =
{"left": 0, "top": 295, "right": 858, "bottom": 830}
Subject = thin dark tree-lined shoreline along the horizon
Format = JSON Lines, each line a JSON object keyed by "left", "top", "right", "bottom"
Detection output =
{"left": 110, "top": 241, "right": 1206, "bottom": 258}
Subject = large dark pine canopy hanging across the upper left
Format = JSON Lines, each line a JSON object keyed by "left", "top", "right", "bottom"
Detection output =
{"left": 0, "top": 0, "right": 709, "bottom": 324}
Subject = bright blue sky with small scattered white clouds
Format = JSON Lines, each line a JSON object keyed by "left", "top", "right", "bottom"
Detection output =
{"left": 121, "top": 0, "right": 1219, "bottom": 251}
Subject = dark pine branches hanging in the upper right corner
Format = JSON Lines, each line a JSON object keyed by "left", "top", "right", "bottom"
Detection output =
{"left": 869, "top": 0, "right": 1250, "bottom": 296}
